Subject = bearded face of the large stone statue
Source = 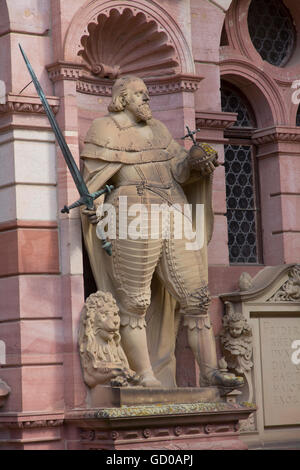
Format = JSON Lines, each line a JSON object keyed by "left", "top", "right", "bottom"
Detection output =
{"left": 125, "top": 80, "right": 152, "bottom": 121}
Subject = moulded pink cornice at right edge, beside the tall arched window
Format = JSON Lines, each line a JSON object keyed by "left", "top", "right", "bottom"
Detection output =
{"left": 252, "top": 126, "right": 300, "bottom": 145}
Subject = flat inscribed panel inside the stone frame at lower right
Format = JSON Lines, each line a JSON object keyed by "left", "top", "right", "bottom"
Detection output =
{"left": 260, "top": 317, "right": 300, "bottom": 426}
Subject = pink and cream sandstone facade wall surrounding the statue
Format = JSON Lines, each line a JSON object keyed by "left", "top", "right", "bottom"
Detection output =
{"left": 0, "top": 0, "right": 300, "bottom": 449}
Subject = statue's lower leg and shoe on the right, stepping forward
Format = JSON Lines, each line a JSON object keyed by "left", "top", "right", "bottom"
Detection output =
{"left": 184, "top": 315, "right": 244, "bottom": 389}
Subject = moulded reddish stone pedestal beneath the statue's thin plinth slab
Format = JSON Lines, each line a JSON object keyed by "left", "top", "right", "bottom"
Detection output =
{"left": 66, "top": 402, "right": 255, "bottom": 451}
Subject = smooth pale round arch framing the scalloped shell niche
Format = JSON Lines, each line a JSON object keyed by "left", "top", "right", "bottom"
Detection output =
{"left": 64, "top": 0, "right": 195, "bottom": 74}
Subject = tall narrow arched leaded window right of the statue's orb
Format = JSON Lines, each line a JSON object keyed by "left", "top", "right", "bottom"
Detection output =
{"left": 221, "top": 82, "right": 261, "bottom": 264}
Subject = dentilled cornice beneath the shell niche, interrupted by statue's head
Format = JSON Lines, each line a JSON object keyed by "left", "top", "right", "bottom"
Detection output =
{"left": 47, "top": 62, "right": 203, "bottom": 96}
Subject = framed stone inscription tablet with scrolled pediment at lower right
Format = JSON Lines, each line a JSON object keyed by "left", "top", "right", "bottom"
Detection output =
{"left": 221, "top": 263, "right": 300, "bottom": 449}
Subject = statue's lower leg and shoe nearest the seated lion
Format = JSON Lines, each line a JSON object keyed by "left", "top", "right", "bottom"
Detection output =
{"left": 120, "top": 315, "right": 162, "bottom": 388}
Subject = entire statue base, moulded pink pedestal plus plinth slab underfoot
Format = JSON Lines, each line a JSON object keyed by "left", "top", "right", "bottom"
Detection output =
{"left": 65, "top": 387, "right": 256, "bottom": 451}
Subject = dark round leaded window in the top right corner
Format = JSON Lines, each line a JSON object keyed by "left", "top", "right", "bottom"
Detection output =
{"left": 248, "top": 0, "right": 296, "bottom": 67}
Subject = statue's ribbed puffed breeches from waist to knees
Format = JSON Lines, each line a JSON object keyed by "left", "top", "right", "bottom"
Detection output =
{"left": 102, "top": 186, "right": 210, "bottom": 327}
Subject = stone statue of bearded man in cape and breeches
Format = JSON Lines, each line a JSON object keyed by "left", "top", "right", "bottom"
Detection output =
{"left": 81, "top": 76, "right": 243, "bottom": 387}
